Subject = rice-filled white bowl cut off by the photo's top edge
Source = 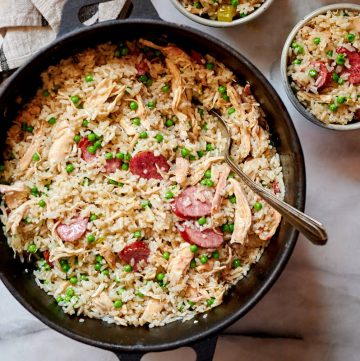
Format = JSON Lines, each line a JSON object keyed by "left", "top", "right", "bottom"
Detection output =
{"left": 171, "top": 0, "right": 274, "bottom": 28}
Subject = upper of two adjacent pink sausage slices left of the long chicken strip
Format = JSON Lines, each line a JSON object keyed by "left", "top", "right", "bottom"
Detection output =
{"left": 172, "top": 186, "right": 213, "bottom": 219}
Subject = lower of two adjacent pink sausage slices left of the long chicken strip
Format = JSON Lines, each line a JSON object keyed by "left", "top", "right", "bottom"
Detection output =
{"left": 180, "top": 226, "right": 224, "bottom": 248}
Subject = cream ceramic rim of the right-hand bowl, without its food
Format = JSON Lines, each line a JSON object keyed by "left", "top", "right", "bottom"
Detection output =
{"left": 280, "top": 3, "right": 360, "bottom": 131}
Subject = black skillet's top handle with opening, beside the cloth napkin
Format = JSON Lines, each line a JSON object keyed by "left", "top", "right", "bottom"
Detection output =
{"left": 57, "top": 0, "right": 160, "bottom": 37}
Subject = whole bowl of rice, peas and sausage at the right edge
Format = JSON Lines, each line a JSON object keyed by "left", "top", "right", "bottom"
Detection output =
{"left": 281, "top": 4, "right": 360, "bottom": 131}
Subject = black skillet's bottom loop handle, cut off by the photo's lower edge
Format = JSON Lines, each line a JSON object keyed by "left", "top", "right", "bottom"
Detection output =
{"left": 115, "top": 335, "right": 218, "bottom": 361}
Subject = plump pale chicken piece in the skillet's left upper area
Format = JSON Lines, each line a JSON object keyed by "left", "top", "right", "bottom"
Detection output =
{"left": 48, "top": 121, "right": 75, "bottom": 168}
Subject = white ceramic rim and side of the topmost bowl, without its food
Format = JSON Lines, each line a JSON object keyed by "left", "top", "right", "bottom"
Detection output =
{"left": 171, "top": 0, "right": 274, "bottom": 28}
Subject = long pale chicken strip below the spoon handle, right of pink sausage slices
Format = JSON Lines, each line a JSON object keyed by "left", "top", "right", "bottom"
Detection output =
{"left": 229, "top": 178, "right": 251, "bottom": 244}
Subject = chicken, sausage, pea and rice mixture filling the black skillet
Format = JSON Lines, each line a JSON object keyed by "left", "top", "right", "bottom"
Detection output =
{"left": 0, "top": 39, "right": 284, "bottom": 327}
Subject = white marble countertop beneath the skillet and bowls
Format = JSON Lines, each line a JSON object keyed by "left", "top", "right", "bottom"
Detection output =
{"left": 0, "top": 0, "right": 360, "bottom": 361}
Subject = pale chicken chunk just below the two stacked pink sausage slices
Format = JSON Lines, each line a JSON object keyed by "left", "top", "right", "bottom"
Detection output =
{"left": 168, "top": 242, "right": 194, "bottom": 286}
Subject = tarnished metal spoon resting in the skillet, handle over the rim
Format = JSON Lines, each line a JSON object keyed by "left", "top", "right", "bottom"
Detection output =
{"left": 210, "top": 110, "right": 327, "bottom": 245}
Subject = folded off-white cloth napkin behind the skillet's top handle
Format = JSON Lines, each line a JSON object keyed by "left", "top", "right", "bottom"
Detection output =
{"left": 0, "top": 0, "right": 125, "bottom": 72}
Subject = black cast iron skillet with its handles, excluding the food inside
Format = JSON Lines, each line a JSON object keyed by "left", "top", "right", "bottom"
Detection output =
{"left": 0, "top": 0, "right": 305, "bottom": 361}
